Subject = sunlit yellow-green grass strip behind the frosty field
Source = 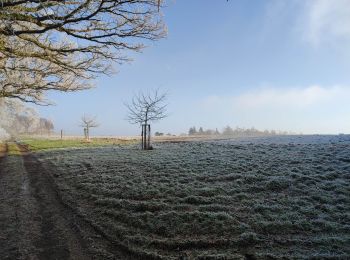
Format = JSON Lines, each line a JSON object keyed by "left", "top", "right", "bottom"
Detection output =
{"left": 22, "top": 138, "right": 136, "bottom": 151}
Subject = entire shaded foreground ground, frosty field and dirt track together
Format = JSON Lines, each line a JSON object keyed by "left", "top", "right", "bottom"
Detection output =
{"left": 0, "top": 135, "right": 350, "bottom": 259}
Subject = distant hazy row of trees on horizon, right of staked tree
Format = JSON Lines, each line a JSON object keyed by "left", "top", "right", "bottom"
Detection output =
{"left": 188, "top": 126, "right": 291, "bottom": 136}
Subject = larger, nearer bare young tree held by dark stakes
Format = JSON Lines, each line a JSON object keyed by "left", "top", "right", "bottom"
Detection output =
{"left": 125, "top": 90, "right": 167, "bottom": 150}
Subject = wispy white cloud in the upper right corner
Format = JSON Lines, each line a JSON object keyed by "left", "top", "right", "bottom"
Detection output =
{"left": 300, "top": 0, "right": 350, "bottom": 46}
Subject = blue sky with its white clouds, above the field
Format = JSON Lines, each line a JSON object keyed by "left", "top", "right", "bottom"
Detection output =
{"left": 38, "top": 0, "right": 350, "bottom": 136}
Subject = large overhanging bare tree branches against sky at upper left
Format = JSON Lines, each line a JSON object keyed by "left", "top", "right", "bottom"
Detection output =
{"left": 0, "top": 0, "right": 166, "bottom": 104}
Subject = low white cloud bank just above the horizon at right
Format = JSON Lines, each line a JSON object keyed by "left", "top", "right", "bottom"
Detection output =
{"left": 200, "top": 85, "right": 350, "bottom": 133}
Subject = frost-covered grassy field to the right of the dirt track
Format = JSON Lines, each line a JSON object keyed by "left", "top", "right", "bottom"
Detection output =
{"left": 36, "top": 136, "right": 350, "bottom": 259}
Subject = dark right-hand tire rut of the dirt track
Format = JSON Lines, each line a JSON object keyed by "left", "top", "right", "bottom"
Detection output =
{"left": 18, "top": 145, "right": 90, "bottom": 260}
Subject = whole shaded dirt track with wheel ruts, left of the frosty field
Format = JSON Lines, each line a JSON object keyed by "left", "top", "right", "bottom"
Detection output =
{"left": 0, "top": 146, "right": 91, "bottom": 260}
